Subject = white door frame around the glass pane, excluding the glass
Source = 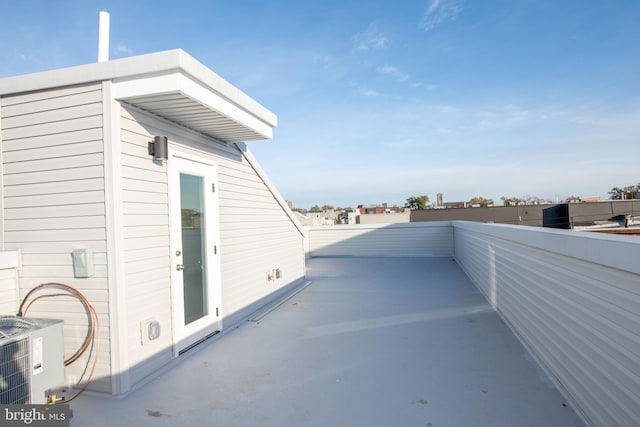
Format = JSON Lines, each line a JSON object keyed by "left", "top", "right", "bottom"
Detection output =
{"left": 167, "top": 147, "right": 222, "bottom": 357}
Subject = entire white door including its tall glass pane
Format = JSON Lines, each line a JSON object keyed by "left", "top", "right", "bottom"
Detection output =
{"left": 168, "top": 153, "right": 222, "bottom": 355}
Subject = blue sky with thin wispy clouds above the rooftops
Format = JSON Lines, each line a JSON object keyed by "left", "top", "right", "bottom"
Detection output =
{"left": 0, "top": 0, "right": 640, "bottom": 208}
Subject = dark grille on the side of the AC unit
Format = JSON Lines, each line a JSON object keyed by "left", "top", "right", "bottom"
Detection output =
{"left": 0, "top": 337, "right": 31, "bottom": 405}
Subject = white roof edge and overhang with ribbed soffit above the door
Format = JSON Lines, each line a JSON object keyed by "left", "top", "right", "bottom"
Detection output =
{"left": 0, "top": 49, "right": 278, "bottom": 142}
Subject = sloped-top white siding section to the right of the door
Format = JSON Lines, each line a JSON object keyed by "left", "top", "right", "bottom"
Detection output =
{"left": 219, "top": 146, "right": 305, "bottom": 321}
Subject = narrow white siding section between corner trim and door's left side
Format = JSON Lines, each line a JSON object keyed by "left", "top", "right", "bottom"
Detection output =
{"left": 119, "top": 108, "right": 173, "bottom": 385}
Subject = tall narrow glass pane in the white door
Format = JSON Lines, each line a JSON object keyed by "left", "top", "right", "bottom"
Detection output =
{"left": 180, "top": 173, "right": 209, "bottom": 325}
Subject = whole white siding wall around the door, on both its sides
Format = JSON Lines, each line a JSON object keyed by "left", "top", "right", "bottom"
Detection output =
{"left": 120, "top": 106, "right": 305, "bottom": 383}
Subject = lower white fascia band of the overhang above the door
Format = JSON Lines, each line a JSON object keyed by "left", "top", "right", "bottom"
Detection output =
{"left": 113, "top": 70, "right": 272, "bottom": 139}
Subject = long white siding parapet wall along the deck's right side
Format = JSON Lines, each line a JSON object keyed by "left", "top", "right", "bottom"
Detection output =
{"left": 454, "top": 222, "right": 640, "bottom": 426}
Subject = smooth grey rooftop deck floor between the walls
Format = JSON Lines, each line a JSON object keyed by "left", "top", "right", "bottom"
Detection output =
{"left": 71, "top": 258, "right": 583, "bottom": 427}
